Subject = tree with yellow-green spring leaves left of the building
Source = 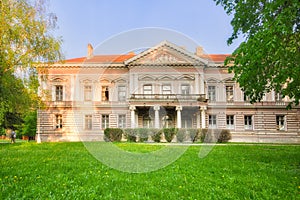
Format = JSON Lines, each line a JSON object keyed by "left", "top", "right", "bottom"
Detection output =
{"left": 0, "top": 0, "right": 62, "bottom": 124}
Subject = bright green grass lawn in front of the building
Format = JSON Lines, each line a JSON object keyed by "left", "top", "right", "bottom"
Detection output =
{"left": 0, "top": 142, "right": 300, "bottom": 200}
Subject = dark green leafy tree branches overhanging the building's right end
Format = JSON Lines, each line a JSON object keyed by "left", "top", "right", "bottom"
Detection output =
{"left": 214, "top": 0, "right": 300, "bottom": 108}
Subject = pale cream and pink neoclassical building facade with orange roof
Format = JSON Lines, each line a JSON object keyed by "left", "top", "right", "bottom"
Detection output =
{"left": 38, "top": 41, "right": 300, "bottom": 140}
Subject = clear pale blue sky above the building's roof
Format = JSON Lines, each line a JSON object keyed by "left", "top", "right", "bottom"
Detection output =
{"left": 49, "top": 0, "right": 240, "bottom": 58}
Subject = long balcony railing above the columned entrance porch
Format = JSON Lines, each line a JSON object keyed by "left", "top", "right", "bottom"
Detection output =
{"left": 130, "top": 94, "right": 207, "bottom": 102}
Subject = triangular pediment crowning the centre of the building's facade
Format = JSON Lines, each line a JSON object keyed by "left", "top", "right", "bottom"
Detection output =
{"left": 125, "top": 41, "right": 207, "bottom": 66}
